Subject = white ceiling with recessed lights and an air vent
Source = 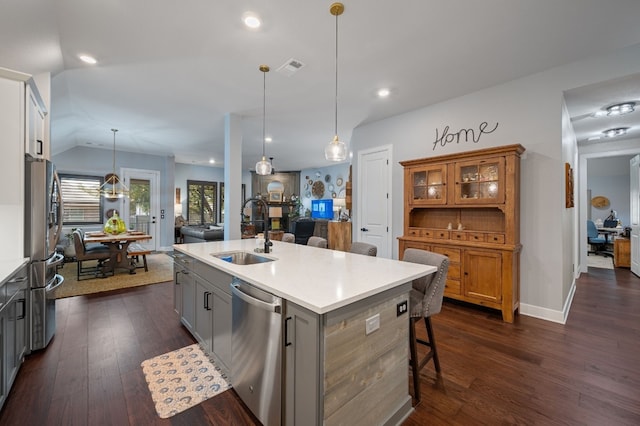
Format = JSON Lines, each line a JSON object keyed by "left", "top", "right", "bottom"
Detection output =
{"left": 0, "top": 0, "right": 640, "bottom": 170}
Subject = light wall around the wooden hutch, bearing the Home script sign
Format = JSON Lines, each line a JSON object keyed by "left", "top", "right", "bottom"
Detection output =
{"left": 351, "top": 45, "right": 640, "bottom": 322}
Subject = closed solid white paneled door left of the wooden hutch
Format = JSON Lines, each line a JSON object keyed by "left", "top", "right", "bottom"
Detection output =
{"left": 355, "top": 145, "right": 393, "bottom": 259}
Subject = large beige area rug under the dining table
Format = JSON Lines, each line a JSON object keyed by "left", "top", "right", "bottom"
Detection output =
{"left": 55, "top": 253, "right": 173, "bottom": 299}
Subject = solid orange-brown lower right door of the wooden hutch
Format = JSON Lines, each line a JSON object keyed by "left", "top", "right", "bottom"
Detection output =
{"left": 462, "top": 250, "right": 502, "bottom": 303}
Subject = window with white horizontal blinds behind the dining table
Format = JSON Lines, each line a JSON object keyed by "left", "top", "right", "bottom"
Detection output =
{"left": 60, "top": 174, "right": 103, "bottom": 225}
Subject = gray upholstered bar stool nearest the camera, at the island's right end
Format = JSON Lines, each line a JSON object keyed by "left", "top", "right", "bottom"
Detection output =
{"left": 402, "top": 248, "right": 449, "bottom": 403}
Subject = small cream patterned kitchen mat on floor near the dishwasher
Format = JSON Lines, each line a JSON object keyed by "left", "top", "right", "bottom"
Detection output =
{"left": 141, "top": 343, "right": 231, "bottom": 419}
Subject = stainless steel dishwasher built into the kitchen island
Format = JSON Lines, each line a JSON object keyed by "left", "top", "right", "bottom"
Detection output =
{"left": 231, "top": 278, "right": 282, "bottom": 426}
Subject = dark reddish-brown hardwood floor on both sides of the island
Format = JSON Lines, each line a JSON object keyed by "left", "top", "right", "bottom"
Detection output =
{"left": 0, "top": 268, "right": 640, "bottom": 426}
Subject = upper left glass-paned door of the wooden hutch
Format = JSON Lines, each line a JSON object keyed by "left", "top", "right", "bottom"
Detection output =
{"left": 405, "top": 164, "right": 447, "bottom": 205}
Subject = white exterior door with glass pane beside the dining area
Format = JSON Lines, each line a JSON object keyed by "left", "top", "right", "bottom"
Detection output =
{"left": 122, "top": 169, "right": 161, "bottom": 251}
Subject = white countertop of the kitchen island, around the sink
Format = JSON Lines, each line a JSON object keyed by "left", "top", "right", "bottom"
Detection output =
{"left": 173, "top": 239, "right": 436, "bottom": 314}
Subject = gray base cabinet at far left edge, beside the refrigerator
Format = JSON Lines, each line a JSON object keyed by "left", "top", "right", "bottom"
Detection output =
{"left": 0, "top": 266, "right": 28, "bottom": 408}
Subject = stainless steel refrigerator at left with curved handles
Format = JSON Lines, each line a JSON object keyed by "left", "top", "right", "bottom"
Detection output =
{"left": 24, "top": 155, "right": 64, "bottom": 351}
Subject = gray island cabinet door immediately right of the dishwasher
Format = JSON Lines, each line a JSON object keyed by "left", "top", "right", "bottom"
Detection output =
{"left": 283, "top": 302, "right": 322, "bottom": 425}
